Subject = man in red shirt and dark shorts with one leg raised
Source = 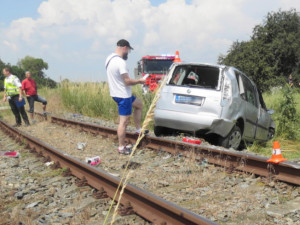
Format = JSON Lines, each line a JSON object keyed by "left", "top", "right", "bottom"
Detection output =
{"left": 22, "top": 71, "right": 47, "bottom": 123}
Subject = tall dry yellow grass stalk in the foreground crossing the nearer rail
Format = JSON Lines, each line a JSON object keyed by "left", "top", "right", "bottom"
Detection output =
{"left": 103, "top": 71, "right": 168, "bottom": 225}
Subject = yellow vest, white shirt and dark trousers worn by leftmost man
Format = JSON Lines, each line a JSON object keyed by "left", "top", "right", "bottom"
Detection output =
{"left": 4, "top": 74, "right": 29, "bottom": 126}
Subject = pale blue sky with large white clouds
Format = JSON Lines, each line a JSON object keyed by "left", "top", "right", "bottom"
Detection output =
{"left": 0, "top": 0, "right": 300, "bottom": 81}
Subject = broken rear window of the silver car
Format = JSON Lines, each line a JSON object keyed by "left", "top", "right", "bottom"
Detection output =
{"left": 169, "top": 65, "right": 220, "bottom": 89}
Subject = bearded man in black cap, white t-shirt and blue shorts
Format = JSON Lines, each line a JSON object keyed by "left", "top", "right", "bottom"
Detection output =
{"left": 105, "top": 39, "right": 145, "bottom": 154}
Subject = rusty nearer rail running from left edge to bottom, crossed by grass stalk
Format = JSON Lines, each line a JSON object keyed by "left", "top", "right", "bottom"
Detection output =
{"left": 0, "top": 120, "right": 215, "bottom": 225}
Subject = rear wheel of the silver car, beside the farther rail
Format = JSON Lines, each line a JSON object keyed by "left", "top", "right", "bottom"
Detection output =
{"left": 220, "top": 126, "right": 243, "bottom": 150}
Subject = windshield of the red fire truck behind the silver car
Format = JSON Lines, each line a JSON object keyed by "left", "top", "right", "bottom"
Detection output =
{"left": 143, "top": 59, "right": 173, "bottom": 74}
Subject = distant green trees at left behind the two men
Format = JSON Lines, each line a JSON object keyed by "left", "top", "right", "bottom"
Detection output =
{"left": 0, "top": 56, "right": 57, "bottom": 91}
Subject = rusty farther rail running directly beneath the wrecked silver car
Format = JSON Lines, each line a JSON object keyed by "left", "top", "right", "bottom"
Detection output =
{"left": 51, "top": 116, "right": 300, "bottom": 185}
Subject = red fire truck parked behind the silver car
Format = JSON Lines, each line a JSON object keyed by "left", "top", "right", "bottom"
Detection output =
{"left": 135, "top": 55, "right": 175, "bottom": 92}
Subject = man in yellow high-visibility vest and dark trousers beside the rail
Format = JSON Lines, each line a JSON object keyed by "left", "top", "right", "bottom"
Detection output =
{"left": 2, "top": 67, "right": 30, "bottom": 127}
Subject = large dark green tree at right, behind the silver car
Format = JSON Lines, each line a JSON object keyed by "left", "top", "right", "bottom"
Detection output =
{"left": 218, "top": 9, "right": 300, "bottom": 90}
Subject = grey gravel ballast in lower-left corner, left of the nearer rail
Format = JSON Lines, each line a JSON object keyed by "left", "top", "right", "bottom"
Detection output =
{"left": 0, "top": 131, "right": 149, "bottom": 225}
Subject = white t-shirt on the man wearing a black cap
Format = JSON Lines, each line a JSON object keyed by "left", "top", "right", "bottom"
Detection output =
{"left": 105, "top": 53, "right": 132, "bottom": 98}
